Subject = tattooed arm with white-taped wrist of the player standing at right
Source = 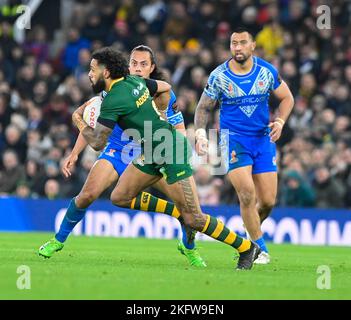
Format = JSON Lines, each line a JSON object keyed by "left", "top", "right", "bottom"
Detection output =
{"left": 195, "top": 93, "right": 217, "bottom": 156}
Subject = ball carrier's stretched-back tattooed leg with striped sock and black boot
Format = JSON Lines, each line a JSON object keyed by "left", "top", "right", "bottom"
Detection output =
{"left": 166, "top": 176, "right": 260, "bottom": 269}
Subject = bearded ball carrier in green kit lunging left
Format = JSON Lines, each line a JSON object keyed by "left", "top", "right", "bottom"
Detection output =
{"left": 72, "top": 48, "right": 260, "bottom": 269}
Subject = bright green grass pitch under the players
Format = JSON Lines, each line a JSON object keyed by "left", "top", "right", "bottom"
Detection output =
{"left": 0, "top": 233, "right": 351, "bottom": 300}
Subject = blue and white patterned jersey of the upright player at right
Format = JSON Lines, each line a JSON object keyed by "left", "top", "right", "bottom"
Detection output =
{"left": 204, "top": 57, "right": 281, "bottom": 136}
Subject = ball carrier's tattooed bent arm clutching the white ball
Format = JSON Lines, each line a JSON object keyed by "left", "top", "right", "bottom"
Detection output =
{"left": 72, "top": 108, "right": 112, "bottom": 151}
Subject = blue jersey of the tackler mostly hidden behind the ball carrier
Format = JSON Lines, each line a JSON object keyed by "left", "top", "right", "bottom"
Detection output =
{"left": 102, "top": 85, "right": 184, "bottom": 151}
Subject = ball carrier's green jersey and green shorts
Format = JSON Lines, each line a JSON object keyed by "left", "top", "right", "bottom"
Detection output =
{"left": 98, "top": 76, "right": 192, "bottom": 184}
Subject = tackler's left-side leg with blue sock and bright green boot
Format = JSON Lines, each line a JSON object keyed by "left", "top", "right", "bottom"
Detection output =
{"left": 38, "top": 159, "right": 118, "bottom": 258}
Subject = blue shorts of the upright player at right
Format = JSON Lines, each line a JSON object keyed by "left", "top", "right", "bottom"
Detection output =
{"left": 221, "top": 135, "right": 277, "bottom": 174}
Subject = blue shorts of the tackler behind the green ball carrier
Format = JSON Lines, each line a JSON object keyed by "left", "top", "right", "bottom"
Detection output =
{"left": 98, "top": 143, "right": 140, "bottom": 176}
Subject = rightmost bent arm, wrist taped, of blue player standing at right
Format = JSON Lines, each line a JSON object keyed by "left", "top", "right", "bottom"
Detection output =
{"left": 269, "top": 81, "right": 294, "bottom": 142}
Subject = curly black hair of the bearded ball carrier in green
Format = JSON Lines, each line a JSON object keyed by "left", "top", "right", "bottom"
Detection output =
{"left": 91, "top": 47, "right": 129, "bottom": 79}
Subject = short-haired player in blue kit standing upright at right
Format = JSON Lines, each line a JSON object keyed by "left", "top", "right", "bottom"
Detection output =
{"left": 195, "top": 29, "right": 294, "bottom": 264}
